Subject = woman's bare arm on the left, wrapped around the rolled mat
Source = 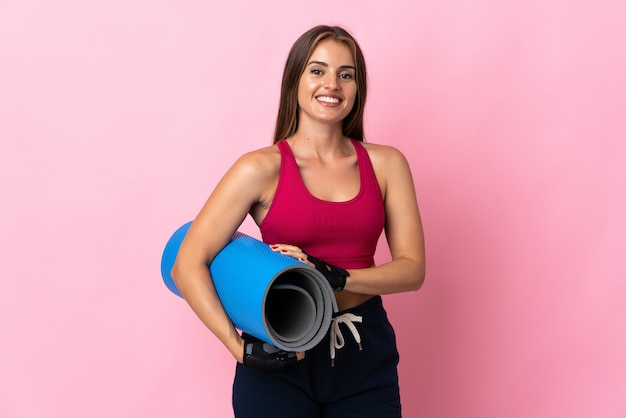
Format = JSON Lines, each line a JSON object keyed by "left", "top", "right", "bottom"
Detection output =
{"left": 171, "top": 151, "right": 272, "bottom": 362}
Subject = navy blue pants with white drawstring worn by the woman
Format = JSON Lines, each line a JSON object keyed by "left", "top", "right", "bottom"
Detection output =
{"left": 233, "top": 296, "right": 402, "bottom": 418}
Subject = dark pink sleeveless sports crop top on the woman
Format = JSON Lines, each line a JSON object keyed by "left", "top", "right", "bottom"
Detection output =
{"left": 260, "top": 140, "right": 385, "bottom": 269}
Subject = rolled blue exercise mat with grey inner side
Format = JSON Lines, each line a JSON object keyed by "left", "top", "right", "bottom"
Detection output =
{"left": 161, "top": 222, "right": 337, "bottom": 351}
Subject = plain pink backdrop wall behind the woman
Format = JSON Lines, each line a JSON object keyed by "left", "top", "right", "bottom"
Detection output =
{"left": 0, "top": 0, "right": 626, "bottom": 418}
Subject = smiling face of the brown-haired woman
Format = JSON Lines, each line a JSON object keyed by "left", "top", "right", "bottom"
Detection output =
{"left": 298, "top": 39, "right": 357, "bottom": 129}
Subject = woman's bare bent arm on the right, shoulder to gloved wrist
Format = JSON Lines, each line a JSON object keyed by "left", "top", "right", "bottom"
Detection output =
{"left": 344, "top": 144, "right": 426, "bottom": 295}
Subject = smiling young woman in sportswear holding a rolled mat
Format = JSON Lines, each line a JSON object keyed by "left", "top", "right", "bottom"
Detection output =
{"left": 172, "top": 26, "right": 425, "bottom": 418}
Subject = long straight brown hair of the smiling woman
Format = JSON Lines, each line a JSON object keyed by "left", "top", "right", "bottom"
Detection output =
{"left": 274, "top": 25, "right": 367, "bottom": 144}
